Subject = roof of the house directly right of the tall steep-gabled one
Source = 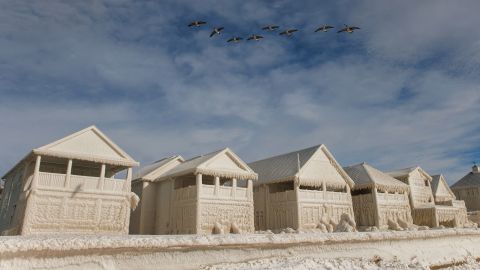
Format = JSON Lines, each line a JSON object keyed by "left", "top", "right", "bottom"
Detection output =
{"left": 343, "top": 162, "right": 409, "bottom": 192}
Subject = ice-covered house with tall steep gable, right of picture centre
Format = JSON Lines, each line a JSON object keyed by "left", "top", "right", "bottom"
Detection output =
{"left": 248, "top": 145, "right": 353, "bottom": 230}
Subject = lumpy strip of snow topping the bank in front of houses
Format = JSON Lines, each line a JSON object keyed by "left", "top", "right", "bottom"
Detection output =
{"left": 0, "top": 229, "right": 480, "bottom": 254}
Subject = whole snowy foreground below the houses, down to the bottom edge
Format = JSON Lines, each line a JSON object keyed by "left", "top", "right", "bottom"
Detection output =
{"left": 0, "top": 229, "right": 480, "bottom": 270}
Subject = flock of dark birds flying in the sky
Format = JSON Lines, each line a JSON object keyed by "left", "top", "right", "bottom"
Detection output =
{"left": 188, "top": 21, "right": 360, "bottom": 43}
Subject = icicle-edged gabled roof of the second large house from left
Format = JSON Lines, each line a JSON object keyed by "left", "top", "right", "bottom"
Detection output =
{"left": 158, "top": 148, "right": 257, "bottom": 181}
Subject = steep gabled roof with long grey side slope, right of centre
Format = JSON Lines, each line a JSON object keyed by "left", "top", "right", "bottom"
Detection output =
{"left": 248, "top": 144, "right": 354, "bottom": 187}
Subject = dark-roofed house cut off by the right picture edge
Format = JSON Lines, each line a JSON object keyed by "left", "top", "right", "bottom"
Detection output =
{"left": 451, "top": 164, "right": 480, "bottom": 212}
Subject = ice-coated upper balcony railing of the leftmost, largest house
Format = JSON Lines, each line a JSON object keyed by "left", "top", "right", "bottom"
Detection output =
{"left": 38, "top": 172, "right": 125, "bottom": 192}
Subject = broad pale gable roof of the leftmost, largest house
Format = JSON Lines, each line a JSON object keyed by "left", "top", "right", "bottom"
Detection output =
{"left": 33, "top": 126, "right": 138, "bottom": 166}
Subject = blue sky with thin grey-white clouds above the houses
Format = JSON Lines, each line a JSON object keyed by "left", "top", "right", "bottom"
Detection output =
{"left": 0, "top": 0, "right": 480, "bottom": 183}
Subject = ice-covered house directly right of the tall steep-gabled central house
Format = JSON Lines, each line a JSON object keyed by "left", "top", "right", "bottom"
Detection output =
{"left": 344, "top": 163, "right": 413, "bottom": 230}
